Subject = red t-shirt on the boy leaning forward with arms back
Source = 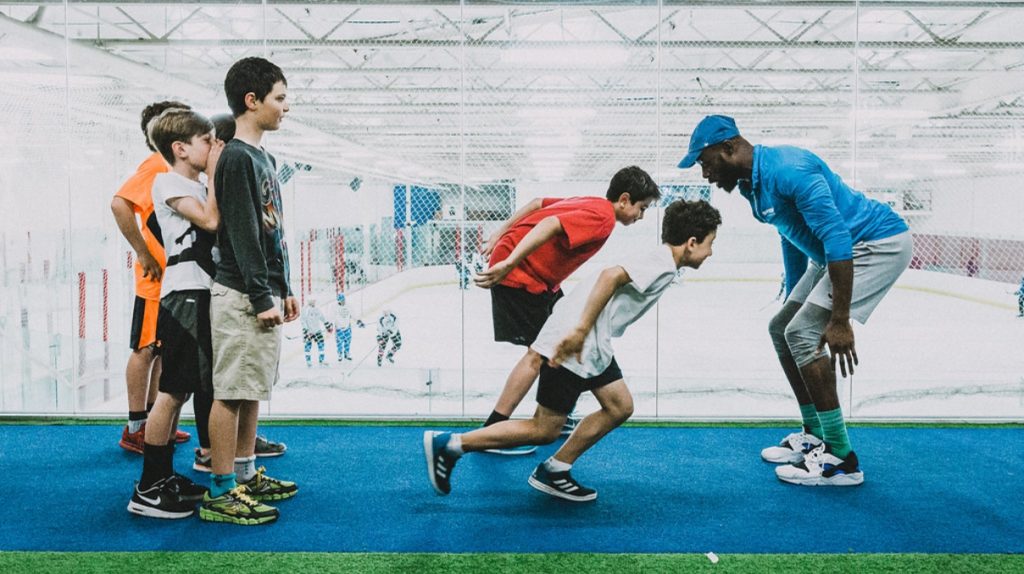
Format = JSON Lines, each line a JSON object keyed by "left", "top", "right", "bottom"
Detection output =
{"left": 490, "top": 197, "right": 615, "bottom": 294}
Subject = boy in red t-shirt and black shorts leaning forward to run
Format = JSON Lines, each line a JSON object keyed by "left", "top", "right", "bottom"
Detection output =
{"left": 473, "top": 166, "right": 662, "bottom": 454}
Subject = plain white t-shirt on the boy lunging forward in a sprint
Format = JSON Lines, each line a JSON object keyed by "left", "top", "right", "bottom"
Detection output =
{"left": 530, "top": 245, "right": 680, "bottom": 379}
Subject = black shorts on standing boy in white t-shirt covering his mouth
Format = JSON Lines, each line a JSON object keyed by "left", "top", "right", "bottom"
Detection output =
{"left": 157, "top": 290, "right": 213, "bottom": 394}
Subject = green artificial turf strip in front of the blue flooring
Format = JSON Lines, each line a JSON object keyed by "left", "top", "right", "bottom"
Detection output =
{"left": 0, "top": 553, "right": 1024, "bottom": 574}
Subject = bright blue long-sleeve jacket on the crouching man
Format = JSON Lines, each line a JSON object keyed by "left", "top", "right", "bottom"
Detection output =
{"left": 739, "top": 145, "right": 908, "bottom": 295}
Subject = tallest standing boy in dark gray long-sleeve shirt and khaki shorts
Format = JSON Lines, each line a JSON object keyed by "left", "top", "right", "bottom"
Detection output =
{"left": 200, "top": 57, "right": 299, "bottom": 525}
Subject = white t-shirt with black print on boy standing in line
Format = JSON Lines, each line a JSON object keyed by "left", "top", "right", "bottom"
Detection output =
{"left": 153, "top": 172, "right": 213, "bottom": 297}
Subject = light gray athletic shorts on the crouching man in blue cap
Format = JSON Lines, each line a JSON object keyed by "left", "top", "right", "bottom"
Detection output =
{"left": 786, "top": 231, "right": 913, "bottom": 324}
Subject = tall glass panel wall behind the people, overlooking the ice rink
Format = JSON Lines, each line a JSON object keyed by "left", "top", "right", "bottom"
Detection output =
{"left": 0, "top": 0, "right": 1024, "bottom": 418}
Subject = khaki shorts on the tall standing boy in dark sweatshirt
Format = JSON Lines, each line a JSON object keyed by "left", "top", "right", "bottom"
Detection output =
{"left": 210, "top": 282, "right": 282, "bottom": 401}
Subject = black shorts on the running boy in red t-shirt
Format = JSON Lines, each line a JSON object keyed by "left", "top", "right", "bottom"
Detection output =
{"left": 490, "top": 285, "right": 562, "bottom": 347}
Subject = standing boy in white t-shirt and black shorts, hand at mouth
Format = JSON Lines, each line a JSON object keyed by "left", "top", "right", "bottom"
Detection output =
{"left": 128, "top": 109, "right": 224, "bottom": 519}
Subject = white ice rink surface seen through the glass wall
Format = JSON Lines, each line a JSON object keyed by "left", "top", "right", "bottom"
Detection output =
{"left": 2, "top": 262, "right": 1024, "bottom": 420}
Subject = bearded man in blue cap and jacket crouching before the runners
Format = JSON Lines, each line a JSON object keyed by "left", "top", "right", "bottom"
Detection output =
{"left": 679, "top": 116, "right": 913, "bottom": 486}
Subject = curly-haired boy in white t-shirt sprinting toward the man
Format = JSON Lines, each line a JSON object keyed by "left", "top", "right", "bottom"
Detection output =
{"left": 423, "top": 201, "right": 722, "bottom": 501}
